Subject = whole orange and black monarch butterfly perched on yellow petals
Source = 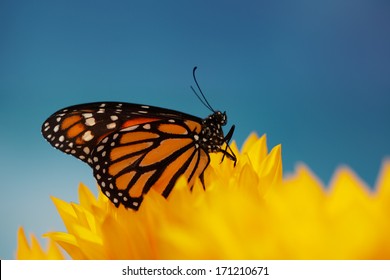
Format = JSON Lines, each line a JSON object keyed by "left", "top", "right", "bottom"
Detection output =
{"left": 42, "top": 67, "right": 236, "bottom": 210}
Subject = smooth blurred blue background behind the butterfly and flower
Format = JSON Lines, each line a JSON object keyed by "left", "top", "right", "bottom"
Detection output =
{"left": 0, "top": 0, "right": 390, "bottom": 258}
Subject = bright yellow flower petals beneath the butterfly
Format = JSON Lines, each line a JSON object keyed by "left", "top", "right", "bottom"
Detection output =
{"left": 16, "top": 134, "right": 390, "bottom": 259}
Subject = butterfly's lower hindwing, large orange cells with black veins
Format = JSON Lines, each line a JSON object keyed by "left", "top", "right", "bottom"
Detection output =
{"left": 91, "top": 119, "right": 209, "bottom": 209}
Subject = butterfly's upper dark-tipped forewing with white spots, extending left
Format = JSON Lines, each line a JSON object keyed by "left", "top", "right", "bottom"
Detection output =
{"left": 42, "top": 102, "right": 203, "bottom": 164}
